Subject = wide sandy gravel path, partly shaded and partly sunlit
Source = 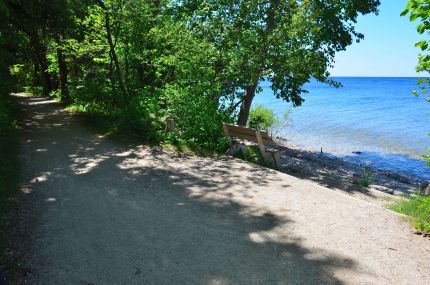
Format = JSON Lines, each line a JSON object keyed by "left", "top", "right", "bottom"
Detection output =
{"left": 10, "top": 94, "right": 430, "bottom": 285}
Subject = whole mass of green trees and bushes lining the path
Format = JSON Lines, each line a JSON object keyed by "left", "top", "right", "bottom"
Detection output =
{"left": 0, "top": 0, "right": 379, "bottom": 148}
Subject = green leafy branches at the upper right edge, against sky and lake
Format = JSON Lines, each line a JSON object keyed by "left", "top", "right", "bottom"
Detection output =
{"left": 400, "top": 0, "right": 430, "bottom": 165}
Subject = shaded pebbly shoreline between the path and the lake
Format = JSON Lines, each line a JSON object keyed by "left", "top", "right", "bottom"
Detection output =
{"left": 274, "top": 137, "right": 428, "bottom": 200}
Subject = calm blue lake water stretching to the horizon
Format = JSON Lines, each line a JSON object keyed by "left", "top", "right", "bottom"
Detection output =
{"left": 253, "top": 77, "right": 430, "bottom": 179}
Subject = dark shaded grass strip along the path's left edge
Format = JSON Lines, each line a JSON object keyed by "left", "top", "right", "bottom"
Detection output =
{"left": 0, "top": 97, "right": 20, "bottom": 276}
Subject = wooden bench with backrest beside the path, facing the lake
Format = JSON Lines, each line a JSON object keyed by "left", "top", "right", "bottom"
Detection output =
{"left": 223, "top": 123, "right": 280, "bottom": 169}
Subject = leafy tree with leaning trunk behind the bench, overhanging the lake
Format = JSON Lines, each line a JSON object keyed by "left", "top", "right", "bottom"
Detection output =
{"left": 178, "top": 0, "right": 379, "bottom": 125}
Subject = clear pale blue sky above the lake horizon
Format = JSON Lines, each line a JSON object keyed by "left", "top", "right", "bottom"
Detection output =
{"left": 331, "top": 0, "right": 423, "bottom": 76}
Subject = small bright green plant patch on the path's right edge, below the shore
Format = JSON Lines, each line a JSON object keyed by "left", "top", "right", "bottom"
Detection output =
{"left": 391, "top": 196, "right": 430, "bottom": 232}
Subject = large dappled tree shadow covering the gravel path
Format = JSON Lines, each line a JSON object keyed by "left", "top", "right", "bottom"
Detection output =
{"left": 15, "top": 97, "right": 356, "bottom": 284}
